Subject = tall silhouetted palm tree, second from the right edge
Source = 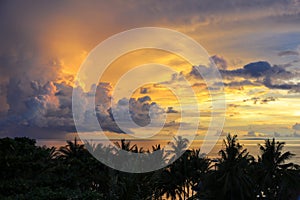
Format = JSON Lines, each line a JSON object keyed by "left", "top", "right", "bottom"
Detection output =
{"left": 206, "top": 134, "right": 255, "bottom": 199}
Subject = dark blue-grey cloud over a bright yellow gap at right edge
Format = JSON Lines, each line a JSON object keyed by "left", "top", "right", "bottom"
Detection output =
{"left": 189, "top": 61, "right": 300, "bottom": 93}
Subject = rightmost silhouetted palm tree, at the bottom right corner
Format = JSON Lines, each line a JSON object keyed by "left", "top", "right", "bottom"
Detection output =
{"left": 257, "top": 138, "right": 300, "bottom": 199}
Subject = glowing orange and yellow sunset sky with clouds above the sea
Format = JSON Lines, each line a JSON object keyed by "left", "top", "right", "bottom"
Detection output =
{"left": 0, "top": 0, "right": 300, "bottom": 139}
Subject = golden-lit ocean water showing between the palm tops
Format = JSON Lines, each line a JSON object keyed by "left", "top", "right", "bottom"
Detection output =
{"left": 37, "top": 137, "right": 300, "bottom": 165}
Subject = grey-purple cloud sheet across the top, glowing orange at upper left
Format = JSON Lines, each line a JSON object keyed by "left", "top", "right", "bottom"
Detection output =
{"left": 0, "top": 0, "right": 299, "bottom": 83}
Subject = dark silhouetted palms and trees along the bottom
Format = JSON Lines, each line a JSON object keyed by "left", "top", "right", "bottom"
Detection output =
{"left": 0, "top": 135, "right": 300, "bottom": 200}
